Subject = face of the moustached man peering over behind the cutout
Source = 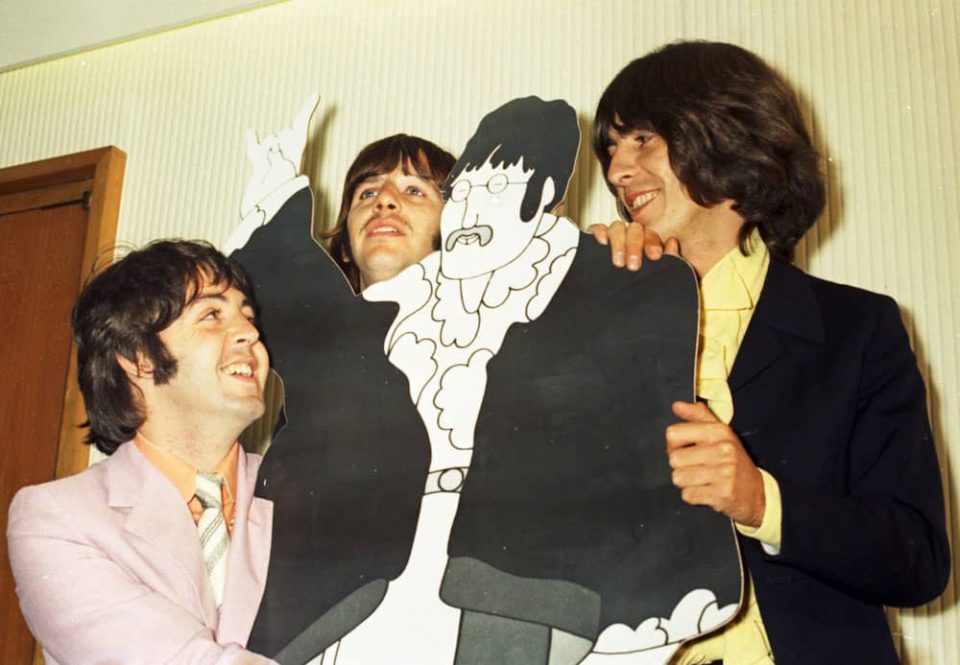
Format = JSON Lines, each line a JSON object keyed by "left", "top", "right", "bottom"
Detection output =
{"left": 347, "top": 165, "right": 443, "bottom": 289}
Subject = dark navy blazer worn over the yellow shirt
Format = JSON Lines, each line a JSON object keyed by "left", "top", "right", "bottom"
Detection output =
{"left": 730, "top": 260, "right": 950, "bottom": 665}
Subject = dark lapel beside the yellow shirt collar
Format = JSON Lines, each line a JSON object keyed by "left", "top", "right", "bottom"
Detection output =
{"left": 728, "top": 258, "right": 824, "bottom": 392}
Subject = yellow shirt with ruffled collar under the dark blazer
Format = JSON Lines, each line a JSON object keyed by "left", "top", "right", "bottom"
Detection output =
{"left": 672, "top": 231, "right": 782, "bottom": 665}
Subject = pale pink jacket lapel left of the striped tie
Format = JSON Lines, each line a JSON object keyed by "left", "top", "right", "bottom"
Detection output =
{"left": 107, "top": 441, "right": 217, "bottom": 629}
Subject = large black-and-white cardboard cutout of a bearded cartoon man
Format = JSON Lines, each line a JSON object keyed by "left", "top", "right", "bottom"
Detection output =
{"left": 230, "top": 97, "right": 740, "bottom": 665}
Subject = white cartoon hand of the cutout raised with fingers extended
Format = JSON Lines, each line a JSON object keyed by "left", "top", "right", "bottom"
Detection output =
{"left": 221, "top": 93, "right": 320, "bottom": 254}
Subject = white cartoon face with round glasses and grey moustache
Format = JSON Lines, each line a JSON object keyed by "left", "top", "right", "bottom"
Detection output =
{"left": 440, "top": 160, "right": 553, "bottom": 279}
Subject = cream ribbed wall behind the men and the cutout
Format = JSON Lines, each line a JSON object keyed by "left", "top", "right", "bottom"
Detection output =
{"left": 0, "top": 0, "right": 960, "bottom": 652}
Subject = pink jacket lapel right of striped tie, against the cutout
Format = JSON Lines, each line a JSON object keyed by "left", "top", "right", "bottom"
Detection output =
{"left": 217, "top": 452, "right": 273, "bottom": 644}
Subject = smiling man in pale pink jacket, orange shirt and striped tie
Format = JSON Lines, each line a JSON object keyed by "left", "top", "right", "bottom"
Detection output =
{"left": 7, "top": 241, "right": 273, "bottom": 663}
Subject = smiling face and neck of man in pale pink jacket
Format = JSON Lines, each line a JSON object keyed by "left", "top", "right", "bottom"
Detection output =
{"left": 148, "top": 280, "right": 270, "bottom": 438}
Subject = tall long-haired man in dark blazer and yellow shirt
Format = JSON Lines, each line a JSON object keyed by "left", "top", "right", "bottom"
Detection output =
{"left": 594, "top": 42, "right": 950, "bottom": 663}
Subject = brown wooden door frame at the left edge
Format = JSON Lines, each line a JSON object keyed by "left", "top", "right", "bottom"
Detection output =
{"left": 0, "top": 146, "right": 127, "bottom": 478}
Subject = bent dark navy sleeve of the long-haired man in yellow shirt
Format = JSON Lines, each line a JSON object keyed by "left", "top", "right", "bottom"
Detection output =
{"left": 776, "top": 298, "right": 950, "bottom": 606}
